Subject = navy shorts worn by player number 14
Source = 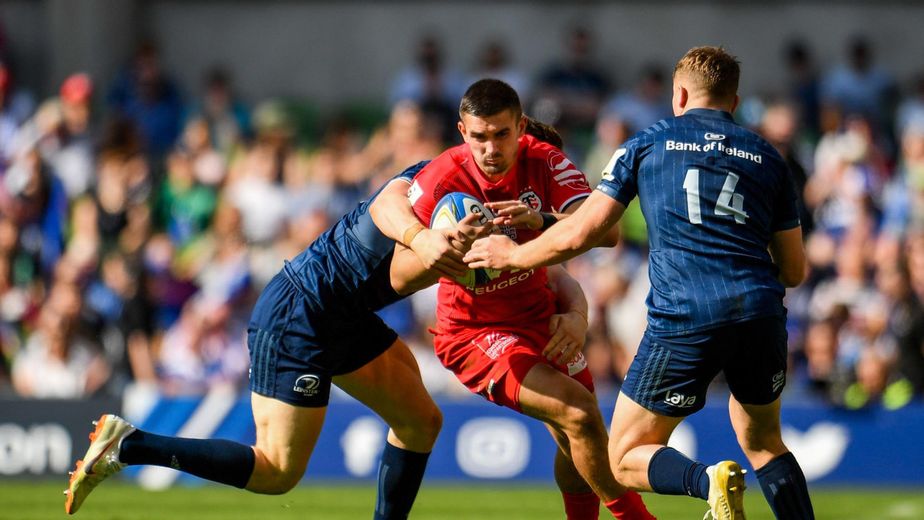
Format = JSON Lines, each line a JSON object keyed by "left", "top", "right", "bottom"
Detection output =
{"left": 622, "top": 316, "right": 787, "bottom": 417}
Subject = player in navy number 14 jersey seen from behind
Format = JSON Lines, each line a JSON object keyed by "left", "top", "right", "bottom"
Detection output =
{"left": 465, "top": 47, "right": 814, "bottom": 519}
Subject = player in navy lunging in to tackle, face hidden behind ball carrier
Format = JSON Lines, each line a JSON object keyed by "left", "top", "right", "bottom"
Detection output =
{"left": 65, "top": 121, "right": 586, "bottom": 519}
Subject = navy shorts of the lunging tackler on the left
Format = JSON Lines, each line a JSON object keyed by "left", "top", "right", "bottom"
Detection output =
{"left": 247, "top": 272, "right": 398, "bottom": 407}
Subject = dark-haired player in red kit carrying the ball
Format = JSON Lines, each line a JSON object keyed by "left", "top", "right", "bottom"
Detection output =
{"left": 370, "top": 79, "right": 653, "bottom": 519}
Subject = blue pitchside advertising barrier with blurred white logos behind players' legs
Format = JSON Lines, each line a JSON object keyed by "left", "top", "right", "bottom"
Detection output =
{"left": 0, "top": 389, "right": 924, "bottom": 489}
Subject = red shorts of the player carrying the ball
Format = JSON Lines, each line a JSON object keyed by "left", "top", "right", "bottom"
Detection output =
{"left": 434, "top": 321, "right": 594, "bottom": 412}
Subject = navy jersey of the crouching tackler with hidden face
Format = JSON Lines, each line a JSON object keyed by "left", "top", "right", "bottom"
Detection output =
{"left": 283, "top": 161, "right": 429, "bottom": 311}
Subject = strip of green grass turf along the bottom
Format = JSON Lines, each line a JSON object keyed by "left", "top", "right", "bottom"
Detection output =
{"left": 7, "top": 481, "right": 924, "bottom": 520}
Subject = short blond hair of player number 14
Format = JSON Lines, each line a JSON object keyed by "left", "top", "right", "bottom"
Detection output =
{"left": 674, "top": 46, "right": 741, "bottom": 101}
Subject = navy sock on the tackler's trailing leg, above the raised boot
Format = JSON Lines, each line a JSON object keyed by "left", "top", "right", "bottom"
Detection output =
{"left": 119, "top": 430, "right": 255, "bottom": 488}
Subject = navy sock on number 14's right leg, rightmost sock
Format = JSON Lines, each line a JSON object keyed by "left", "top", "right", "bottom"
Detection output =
{"left": 756, "top": 452, "right": 815, "bottom": 520}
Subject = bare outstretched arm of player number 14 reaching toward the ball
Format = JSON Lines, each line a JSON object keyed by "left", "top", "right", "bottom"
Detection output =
{"left": 465, "top": 191, "right": 626, "bottom": 270}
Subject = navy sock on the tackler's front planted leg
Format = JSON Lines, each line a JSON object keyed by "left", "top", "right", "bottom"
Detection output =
{"left": 373, "top": 442, "right": 430, "bottom": 520}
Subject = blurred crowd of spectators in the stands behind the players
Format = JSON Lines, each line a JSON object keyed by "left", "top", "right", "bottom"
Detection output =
{"left": 0, "top": 27, "right": 924, "bottom": 408}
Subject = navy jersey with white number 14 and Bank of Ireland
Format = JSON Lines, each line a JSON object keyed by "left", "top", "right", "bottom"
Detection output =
{"left": 597, "top": 109, "right": 799, "bottom": 333}
